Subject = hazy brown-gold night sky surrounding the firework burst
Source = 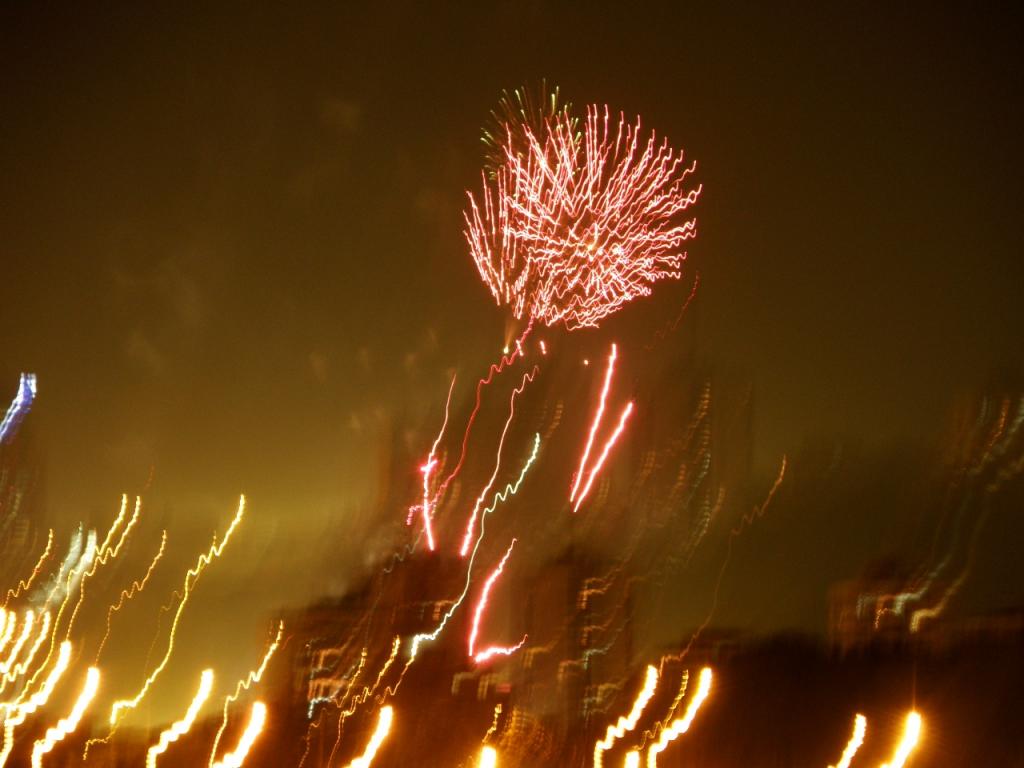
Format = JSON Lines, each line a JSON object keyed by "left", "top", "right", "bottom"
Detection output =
{"left": 0, "top": 2, "right": 1024, "bottom": 716}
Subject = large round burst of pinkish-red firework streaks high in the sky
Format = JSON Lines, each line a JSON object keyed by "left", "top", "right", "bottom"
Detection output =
{"left": 463, "top": 105, "right": 700, "bottom": 331}
